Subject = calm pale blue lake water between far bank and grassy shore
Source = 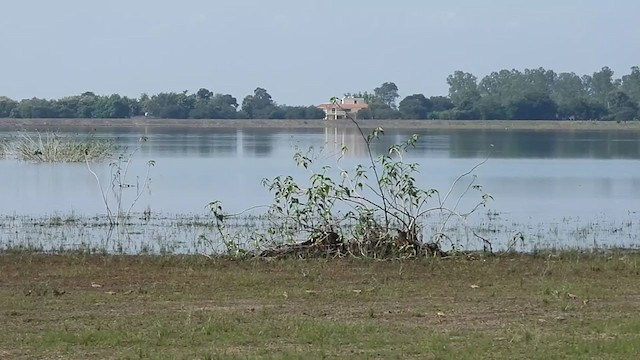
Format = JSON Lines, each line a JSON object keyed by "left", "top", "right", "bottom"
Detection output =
{"left": 0, "top": 128, "right": 640, "bottom": 251}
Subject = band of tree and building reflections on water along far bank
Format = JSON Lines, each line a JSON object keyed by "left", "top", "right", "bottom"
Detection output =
{"left": 0, "top": 127, "right": 640, "bottom": 159}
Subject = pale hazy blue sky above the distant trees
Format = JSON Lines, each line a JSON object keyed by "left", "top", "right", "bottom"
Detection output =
{"left": 0, "top": 0, "right": 640, "bottom": 105}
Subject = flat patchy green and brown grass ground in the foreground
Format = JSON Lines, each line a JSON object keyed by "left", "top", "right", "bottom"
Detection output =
{"left": 0, "top": 252, "right": 640, "bottom": 359}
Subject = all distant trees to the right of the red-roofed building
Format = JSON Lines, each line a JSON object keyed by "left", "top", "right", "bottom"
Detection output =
{"left": 355, "top": 66, "right": 640, "bottom": 121}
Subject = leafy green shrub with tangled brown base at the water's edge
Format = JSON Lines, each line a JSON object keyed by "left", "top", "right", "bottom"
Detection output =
{"left": 209, "top": 97, "right": 492, "bottom": 258}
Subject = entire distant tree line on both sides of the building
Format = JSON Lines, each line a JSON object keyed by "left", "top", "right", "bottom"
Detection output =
{"left": 0, "top": 66, "right": 640, "bottom": 121}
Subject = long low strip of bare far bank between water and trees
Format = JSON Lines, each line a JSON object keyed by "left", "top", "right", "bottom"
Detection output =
{"left": 0, "top": 118, "right": 640, "bottom": 131}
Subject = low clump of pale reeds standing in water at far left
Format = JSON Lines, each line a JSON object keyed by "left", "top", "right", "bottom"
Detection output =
{"left": 14, "top": 132, "right": 115, "bottom": 162}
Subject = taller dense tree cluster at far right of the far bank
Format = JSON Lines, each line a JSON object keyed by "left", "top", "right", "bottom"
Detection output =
{"left": 436, "top": 67, "right": 640, "bottom": 120}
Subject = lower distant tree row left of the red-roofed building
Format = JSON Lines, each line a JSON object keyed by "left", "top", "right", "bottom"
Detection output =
{"left": 0, "top": 88, "right": 324, "bottom": 119}
